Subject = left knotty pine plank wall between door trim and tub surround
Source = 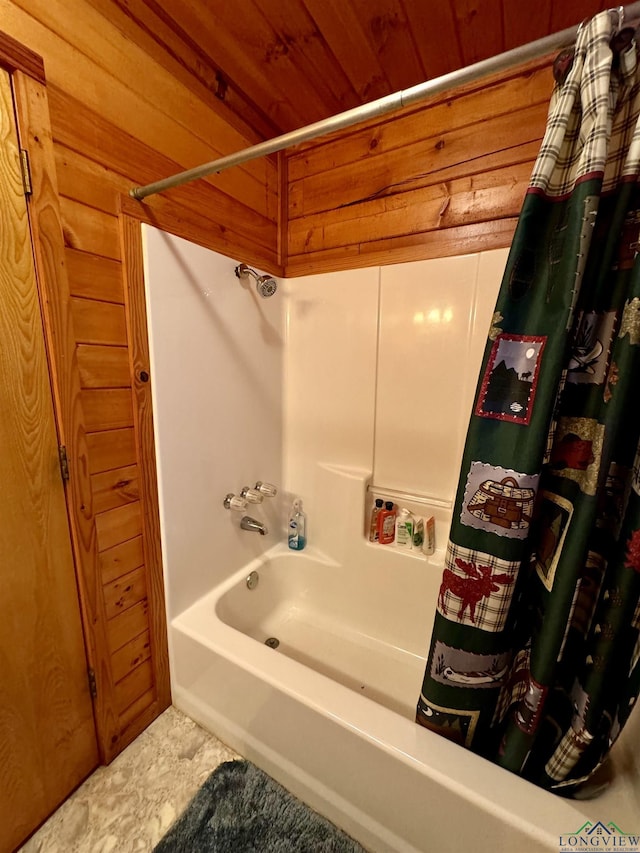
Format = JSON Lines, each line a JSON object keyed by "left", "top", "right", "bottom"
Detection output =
{"left": 0, "top": 0, "right": 281, "bottom": 760}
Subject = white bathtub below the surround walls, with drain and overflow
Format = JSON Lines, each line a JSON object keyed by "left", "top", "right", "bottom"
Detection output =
{"left": 170, "top": 545, "right": 640, "bottom": 853}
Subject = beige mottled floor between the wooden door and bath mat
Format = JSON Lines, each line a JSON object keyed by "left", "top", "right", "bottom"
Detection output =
{"left": 18, "top": 708, "right": 240, "bottom": 853}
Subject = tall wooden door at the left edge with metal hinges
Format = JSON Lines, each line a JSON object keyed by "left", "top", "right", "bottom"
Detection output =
{"left": 0, "top": 70, "right": 98, "bottom": 853}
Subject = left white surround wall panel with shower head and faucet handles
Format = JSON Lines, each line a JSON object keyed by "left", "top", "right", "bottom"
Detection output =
{"left": 143, "top": 226, "right": 285, "bottom": 616}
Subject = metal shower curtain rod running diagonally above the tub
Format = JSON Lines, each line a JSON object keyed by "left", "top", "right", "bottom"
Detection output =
{"left": 129, "top": 0, "right": 640, "bottom": 199}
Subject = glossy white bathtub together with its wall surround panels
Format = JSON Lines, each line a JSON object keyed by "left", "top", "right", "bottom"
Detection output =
{"left": 149, "top": 238, "right": 640, "bottom": 853}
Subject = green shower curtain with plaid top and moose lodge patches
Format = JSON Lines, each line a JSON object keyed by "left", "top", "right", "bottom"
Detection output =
{"left": 416, "top": 12, "right": 640, "bottom": 795}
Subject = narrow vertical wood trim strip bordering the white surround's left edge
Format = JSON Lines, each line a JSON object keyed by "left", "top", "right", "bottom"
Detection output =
{"left": 119, "top": 214, "right": 171, "bottom": 708}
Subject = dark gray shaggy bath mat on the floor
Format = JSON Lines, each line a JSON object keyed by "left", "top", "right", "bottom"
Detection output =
{"left": 154, "top": 761, "right": 365, "bottom": 853}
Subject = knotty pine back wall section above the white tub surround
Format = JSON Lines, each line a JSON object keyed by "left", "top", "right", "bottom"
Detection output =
{"left": 287, "top": 58, "right": 553, "bottom": 276}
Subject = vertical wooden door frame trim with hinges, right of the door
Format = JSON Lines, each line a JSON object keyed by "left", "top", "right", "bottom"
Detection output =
{"left": 14, "top": 72, "right": 119, "bottom": 760}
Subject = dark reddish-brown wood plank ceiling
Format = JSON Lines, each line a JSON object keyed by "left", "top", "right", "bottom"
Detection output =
{"left": 95, "top": 0, "right": 607, "bottom": 140}
